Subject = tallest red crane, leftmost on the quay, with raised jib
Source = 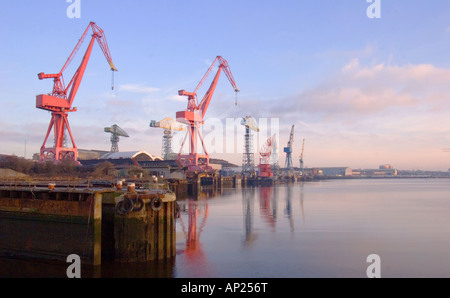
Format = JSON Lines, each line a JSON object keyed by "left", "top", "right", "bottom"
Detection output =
{"left": 36, "top": 22, "right": 117, "bottom": 162}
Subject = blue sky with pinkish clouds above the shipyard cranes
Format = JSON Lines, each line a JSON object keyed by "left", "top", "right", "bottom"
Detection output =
{"left": 0, "top": 0, "right": 450, "bottom": 171}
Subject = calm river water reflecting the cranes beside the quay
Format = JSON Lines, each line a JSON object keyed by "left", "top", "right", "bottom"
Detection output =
{"left": 0, "top": 178, "right": 450, "bottom": 278}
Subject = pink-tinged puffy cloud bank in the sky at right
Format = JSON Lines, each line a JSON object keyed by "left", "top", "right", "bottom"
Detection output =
{"left": 270, "top": 59, "right": 450, "bottom": 121}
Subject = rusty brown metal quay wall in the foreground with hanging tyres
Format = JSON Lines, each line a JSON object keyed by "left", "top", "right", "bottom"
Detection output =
{"left": 0, "top": 185, "right": 176, "bottom": 264}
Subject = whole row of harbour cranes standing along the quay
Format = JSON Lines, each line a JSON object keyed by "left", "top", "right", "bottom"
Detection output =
{"left": 36, "top": 22, "right": 304, "bottom": 182}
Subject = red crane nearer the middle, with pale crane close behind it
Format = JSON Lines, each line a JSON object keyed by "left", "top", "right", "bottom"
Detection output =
{"left": 176, "top": 56, "right": 239, "bottom": 172}
